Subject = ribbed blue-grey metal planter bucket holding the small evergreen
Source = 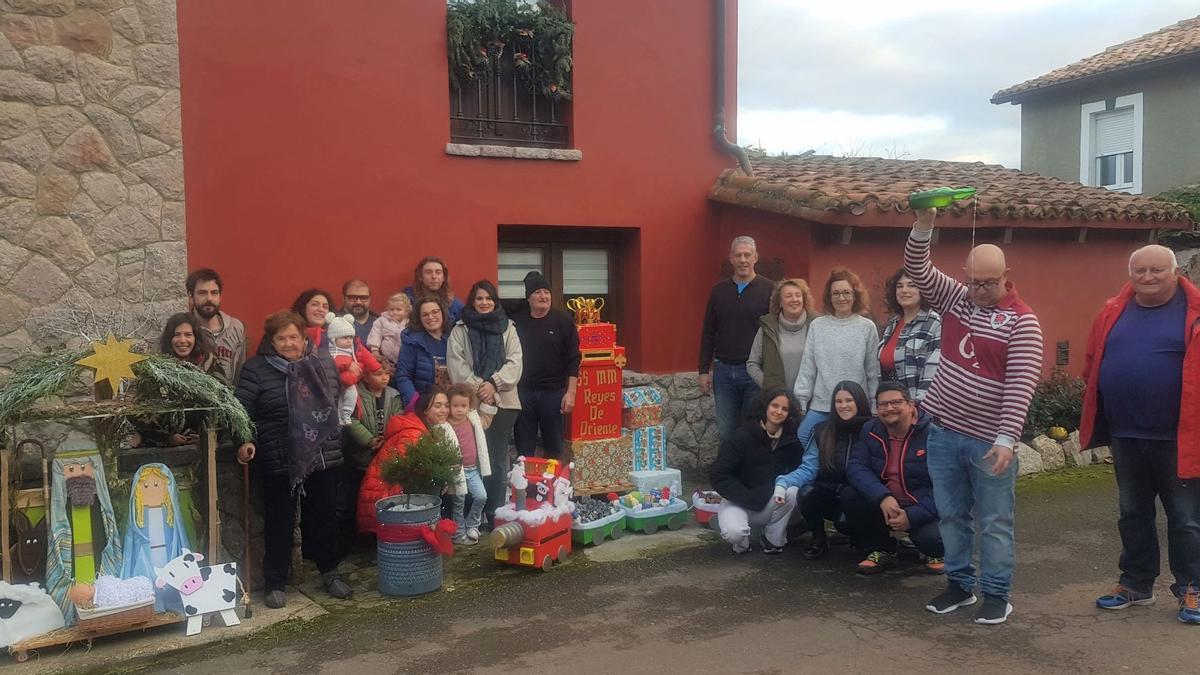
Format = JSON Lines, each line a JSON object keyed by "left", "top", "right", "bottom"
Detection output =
{"left": 376, "top": 495, "right": 442, "bottom": 597}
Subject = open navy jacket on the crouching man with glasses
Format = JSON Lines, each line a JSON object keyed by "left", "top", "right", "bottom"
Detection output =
{"left": 846, "top": 413, "right": 937, "bottom": 530}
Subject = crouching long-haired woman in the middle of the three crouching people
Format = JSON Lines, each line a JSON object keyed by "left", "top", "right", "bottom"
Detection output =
{"left": 799, "top": 380, "right": 871, "bottom": 560}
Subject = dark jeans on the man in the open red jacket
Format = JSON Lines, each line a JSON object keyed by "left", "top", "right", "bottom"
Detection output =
{"left": 1112, "top": 438, "right": 1200, "bottom": 597}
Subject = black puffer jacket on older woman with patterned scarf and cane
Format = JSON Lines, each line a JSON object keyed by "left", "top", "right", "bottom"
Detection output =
{"left": 234, "top": 339, "right": 342, "bottom": 476}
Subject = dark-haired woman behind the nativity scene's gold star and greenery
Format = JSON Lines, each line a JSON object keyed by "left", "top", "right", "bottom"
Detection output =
{"left": 130, "top": 312, "right": 226, "bottom": 448}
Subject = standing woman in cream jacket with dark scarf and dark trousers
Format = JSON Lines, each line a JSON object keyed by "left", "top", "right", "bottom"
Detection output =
{"left": 446, "top": 279, "right": 522, "bottom": 524}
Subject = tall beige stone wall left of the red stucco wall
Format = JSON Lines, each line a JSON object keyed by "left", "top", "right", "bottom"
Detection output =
{"left": 0, "top": 0, "right": 187, "bottom": 372}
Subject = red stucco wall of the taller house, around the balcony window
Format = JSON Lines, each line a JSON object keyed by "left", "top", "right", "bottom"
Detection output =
{"left": 179, "top": 0, "right": 737, "bottom": 371}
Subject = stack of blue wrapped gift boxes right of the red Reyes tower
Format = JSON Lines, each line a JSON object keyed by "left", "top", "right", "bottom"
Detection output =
{"left": 620, "top": 387, "right": 683, "bottom": 496}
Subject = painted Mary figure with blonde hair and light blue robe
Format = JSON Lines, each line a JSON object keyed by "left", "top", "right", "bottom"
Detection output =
{"left": 121, "top": 464, "right": 191, "bottom": 611}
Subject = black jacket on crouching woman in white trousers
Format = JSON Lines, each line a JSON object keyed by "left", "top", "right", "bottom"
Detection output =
{"left": 709, "top": 422, "right": 804, "bottom": 512}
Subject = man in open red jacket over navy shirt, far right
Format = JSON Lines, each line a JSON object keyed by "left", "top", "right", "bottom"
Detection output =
{"left": 1079, "top": 245, "right": 1200, "bottom": 626}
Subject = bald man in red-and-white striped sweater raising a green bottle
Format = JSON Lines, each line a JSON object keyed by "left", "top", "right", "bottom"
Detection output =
{"left": 904, "top": 209, "right": 1042, "bottom": 625}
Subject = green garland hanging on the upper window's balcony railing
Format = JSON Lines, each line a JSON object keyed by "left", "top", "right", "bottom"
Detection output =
{"left": 446, "top": 0, "right": 575, "bottom": 100}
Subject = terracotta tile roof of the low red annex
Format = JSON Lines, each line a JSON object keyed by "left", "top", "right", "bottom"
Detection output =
{"left": 709, "top": 156, "right": 1192, "bottom": 228}
